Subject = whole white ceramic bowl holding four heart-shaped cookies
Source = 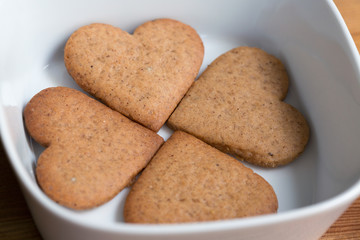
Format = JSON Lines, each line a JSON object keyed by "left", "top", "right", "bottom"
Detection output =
{"left": 0, "top": 0, "right": 360, "bottom": 240}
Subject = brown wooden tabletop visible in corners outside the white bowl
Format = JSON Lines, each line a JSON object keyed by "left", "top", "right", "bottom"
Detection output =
{"left": 0, "top": 0, "right": 360, "bottom": 240}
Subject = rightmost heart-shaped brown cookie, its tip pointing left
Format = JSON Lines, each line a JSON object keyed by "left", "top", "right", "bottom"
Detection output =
{"left": 168, "top": 47, "right": 310, "bottom": 167}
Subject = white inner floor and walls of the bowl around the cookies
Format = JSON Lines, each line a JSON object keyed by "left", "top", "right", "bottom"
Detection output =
{"left": 0, "top": 0, "right": 360, "bottom": 225}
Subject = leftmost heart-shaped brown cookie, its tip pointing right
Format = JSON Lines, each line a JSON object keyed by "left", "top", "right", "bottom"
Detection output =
{"left": 24, "top": 87, "right": 163, "bottom": 210}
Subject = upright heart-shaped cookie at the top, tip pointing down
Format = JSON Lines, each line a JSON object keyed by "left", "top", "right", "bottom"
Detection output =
{"left": 64, "top": 19, "right": 204, "bottom": 131}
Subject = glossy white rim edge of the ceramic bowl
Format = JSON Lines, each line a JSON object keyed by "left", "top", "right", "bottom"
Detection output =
{"left": 0, "top": 0, "right": 360, "bottom": 235}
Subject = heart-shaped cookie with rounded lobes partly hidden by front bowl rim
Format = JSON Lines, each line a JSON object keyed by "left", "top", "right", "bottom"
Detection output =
{"left": 124, "top": 131, "right": 278, "bottom": 223}
